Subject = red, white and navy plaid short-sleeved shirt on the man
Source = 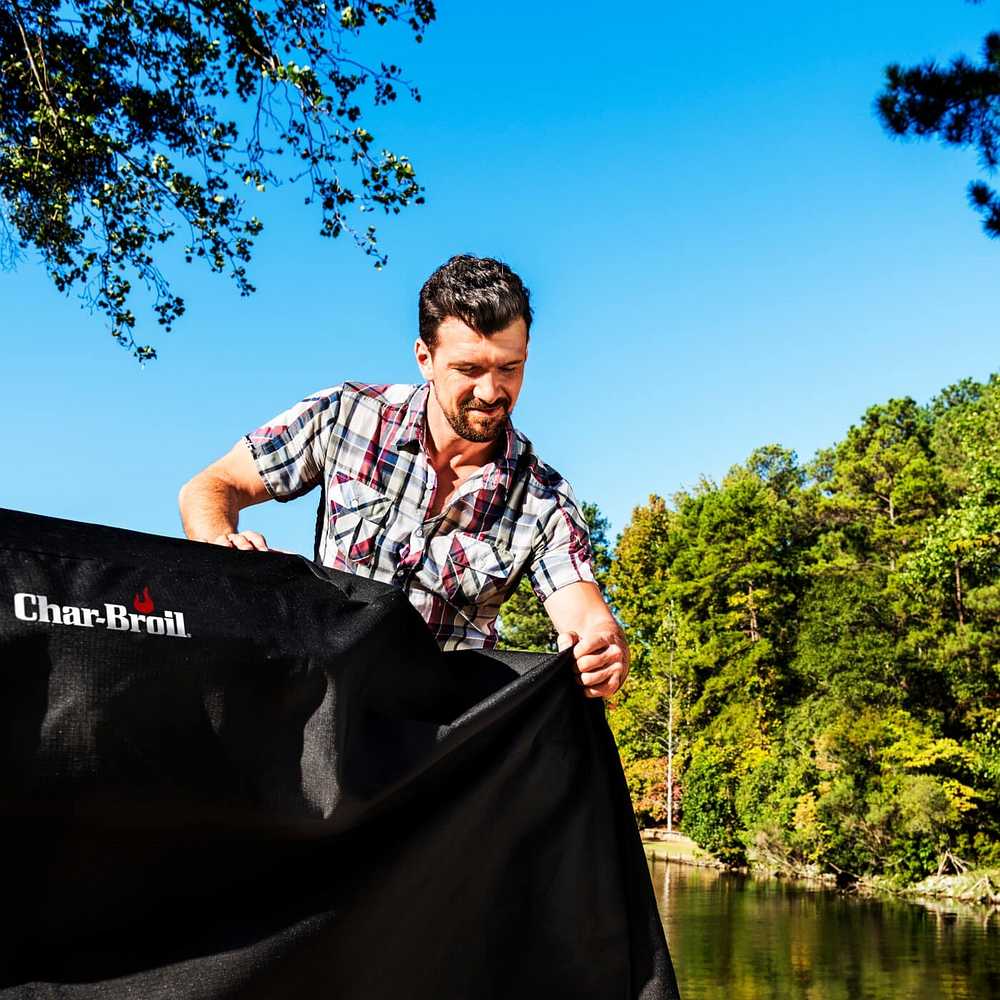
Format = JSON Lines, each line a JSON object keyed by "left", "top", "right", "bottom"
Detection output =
{"left": 246, "top": 382, "right": 594, "bottom": 649}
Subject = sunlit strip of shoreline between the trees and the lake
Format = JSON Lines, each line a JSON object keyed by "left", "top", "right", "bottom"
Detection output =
{"left": 639, "top": 829, "right": 1000, "bottom": 918}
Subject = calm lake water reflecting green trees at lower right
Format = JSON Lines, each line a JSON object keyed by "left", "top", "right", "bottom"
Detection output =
{"left": 649, "top": 861, "right": 1000, "bottom": 1000}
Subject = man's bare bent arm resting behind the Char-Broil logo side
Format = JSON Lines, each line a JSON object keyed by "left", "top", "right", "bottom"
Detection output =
{"left": 177, "top": 441, "right": 271, "bottom": 552}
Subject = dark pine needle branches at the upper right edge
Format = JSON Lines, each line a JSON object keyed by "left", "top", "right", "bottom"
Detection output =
{"left": 875, "top": 0, "right": 1000, "bottom": 239}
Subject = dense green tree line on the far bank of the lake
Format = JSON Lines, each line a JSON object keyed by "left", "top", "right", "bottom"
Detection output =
{"left": 501, "top": 375, "right": 1000, "bottom": 884}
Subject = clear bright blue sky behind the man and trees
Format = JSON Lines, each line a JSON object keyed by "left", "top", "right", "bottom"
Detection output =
{"left": 0, "top": 0, "right": 1000, "bottom": 553}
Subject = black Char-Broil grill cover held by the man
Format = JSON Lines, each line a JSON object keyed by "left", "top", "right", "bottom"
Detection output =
{"left": 0, "top": 511, "right": 677, "bottom": 1000}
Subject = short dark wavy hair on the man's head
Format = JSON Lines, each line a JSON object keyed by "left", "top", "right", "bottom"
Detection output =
{"left": 420, "top": 254, "right": 531, "bottom": 350}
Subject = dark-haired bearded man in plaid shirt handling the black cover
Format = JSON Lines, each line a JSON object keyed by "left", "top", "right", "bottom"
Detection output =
{"left": 179, "top": 256, "right": 628, "bottom": 698}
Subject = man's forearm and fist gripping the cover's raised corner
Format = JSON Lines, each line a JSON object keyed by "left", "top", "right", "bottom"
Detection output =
{"left": 544, "top": 581, "right": 629, "bottom": 698}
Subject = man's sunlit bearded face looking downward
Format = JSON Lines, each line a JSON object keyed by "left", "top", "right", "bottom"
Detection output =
{"left": 416, "top": 316, "right": 528, "bottom": 441}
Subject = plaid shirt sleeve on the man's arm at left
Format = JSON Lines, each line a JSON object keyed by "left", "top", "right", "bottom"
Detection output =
{"left": 244, "top": 385, "right": 341, "bottom": 502}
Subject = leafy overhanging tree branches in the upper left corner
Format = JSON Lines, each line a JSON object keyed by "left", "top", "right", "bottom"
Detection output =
{"left": 0, "top": 0, "right": 435, "bottom": 360}
